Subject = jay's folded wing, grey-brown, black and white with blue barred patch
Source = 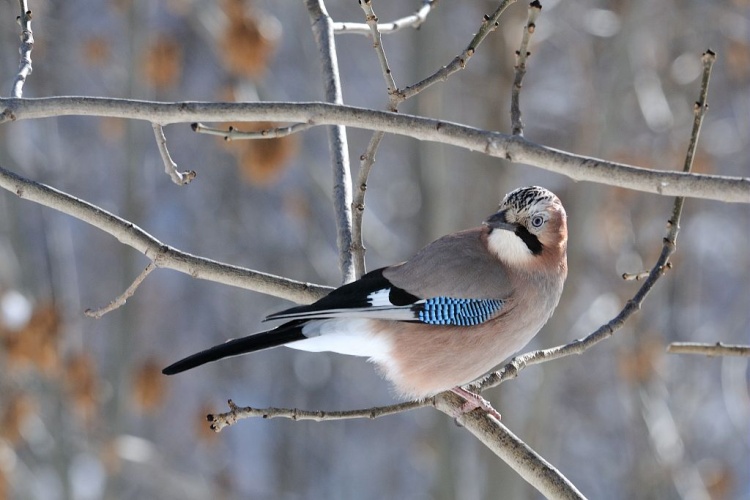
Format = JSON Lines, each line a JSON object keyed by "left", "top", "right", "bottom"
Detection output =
{"left": 266, "top": 228, "right": 510, "bottom": 326}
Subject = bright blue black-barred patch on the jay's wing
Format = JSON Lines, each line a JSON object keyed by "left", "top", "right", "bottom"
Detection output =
{"left": 412, "top": 297, "right": 503, "bottom": 326}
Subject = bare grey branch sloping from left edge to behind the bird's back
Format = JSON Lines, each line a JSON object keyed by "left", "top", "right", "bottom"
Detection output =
{"left": 0, "top": 167, "right": 331, "bottom": 304}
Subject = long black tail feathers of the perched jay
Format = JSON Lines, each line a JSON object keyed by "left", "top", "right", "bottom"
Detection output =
{"left": 161, "top": 321, "right": 307, "bottom": 375}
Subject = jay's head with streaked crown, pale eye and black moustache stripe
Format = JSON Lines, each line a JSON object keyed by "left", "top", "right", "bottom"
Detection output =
{"left": 484, "top": 186, "right": 568, "bottom": 267}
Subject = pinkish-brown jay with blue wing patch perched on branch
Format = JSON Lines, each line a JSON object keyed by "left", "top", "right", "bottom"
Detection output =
{"left": 163, "top": 186, "right": 568, "bottom": 418}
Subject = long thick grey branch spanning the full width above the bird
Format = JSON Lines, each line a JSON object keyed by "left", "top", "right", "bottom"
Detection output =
{"left": 0, "top": 97, "right": 750, "bottom": 203}
